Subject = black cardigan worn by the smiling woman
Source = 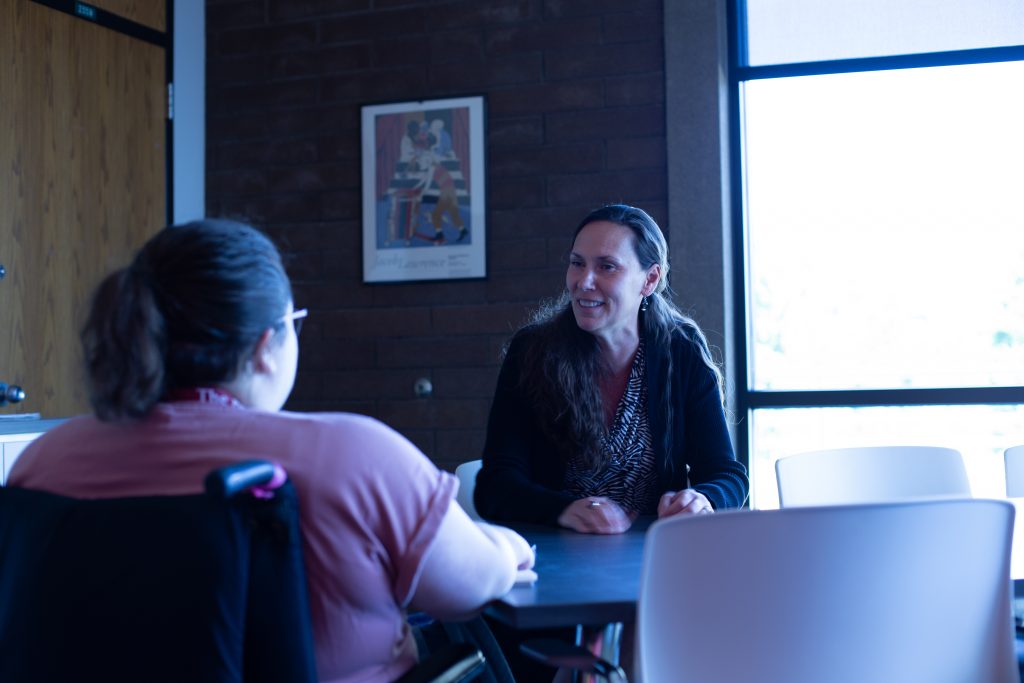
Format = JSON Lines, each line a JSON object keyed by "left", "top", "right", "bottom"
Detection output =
{"left": 473, "top": 330, "right": 749, "bottom": 524}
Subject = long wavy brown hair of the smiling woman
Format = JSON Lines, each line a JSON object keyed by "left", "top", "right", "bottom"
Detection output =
{"left": 519, "top": 204, "right": 722, "bottom": 470}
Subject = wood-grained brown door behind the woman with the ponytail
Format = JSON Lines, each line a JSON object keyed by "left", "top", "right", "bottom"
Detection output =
{"left": 0, "top": 0, "right": 169, "bottom": 418}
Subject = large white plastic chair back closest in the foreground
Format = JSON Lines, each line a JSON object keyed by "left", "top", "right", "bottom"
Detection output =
{"left": 637, "top": 499, "right": 1019, "bottom": 683}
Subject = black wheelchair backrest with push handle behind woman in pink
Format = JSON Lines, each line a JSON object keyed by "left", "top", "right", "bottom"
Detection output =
{"left": 0, "top": 463, "right": 316, "bottom": 682}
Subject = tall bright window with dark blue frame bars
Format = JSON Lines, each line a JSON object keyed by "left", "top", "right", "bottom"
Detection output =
{"left": 732, "top": 0, "right": 1024, "bottom": 508}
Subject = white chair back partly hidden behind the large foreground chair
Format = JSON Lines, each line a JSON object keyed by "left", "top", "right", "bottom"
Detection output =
{"left": 775, "top": 445, "right": 971, "bottom": 507}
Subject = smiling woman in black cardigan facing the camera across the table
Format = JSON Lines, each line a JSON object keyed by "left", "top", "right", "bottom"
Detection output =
{"left": 474, "top": 205, "right": 749, "bottom": 533}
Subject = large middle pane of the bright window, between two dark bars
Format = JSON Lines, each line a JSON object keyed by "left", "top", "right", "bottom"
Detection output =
{"left": 742, "top": 62, "right": 1024, "bottom": 393}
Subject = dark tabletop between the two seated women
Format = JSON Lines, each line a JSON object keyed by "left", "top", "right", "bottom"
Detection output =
{"left": 487, "top": 518, "right": 653, "bottom": 629}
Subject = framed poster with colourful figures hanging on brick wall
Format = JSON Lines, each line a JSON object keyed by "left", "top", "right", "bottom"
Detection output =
{"left": 361, "top": 96, "right": 486, "bottom": 283}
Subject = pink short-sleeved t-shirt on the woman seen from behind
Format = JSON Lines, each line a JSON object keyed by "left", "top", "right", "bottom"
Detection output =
{"left": 9, "top": 402, "right": 458, "bottom": 683}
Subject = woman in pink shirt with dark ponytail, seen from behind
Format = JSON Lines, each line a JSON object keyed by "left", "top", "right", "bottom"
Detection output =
{"left": 10, "top": 220, "right": 534, "bottom": 682}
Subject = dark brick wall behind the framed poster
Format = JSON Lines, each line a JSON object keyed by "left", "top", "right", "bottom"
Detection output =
{"left": 207, "top": 0, "right": 668, "bottom": 469}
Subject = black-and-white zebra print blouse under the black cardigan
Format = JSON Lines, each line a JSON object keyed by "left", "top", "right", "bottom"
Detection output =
{"left": 564, "top": 341, "right": 658, "bottom": 514}
